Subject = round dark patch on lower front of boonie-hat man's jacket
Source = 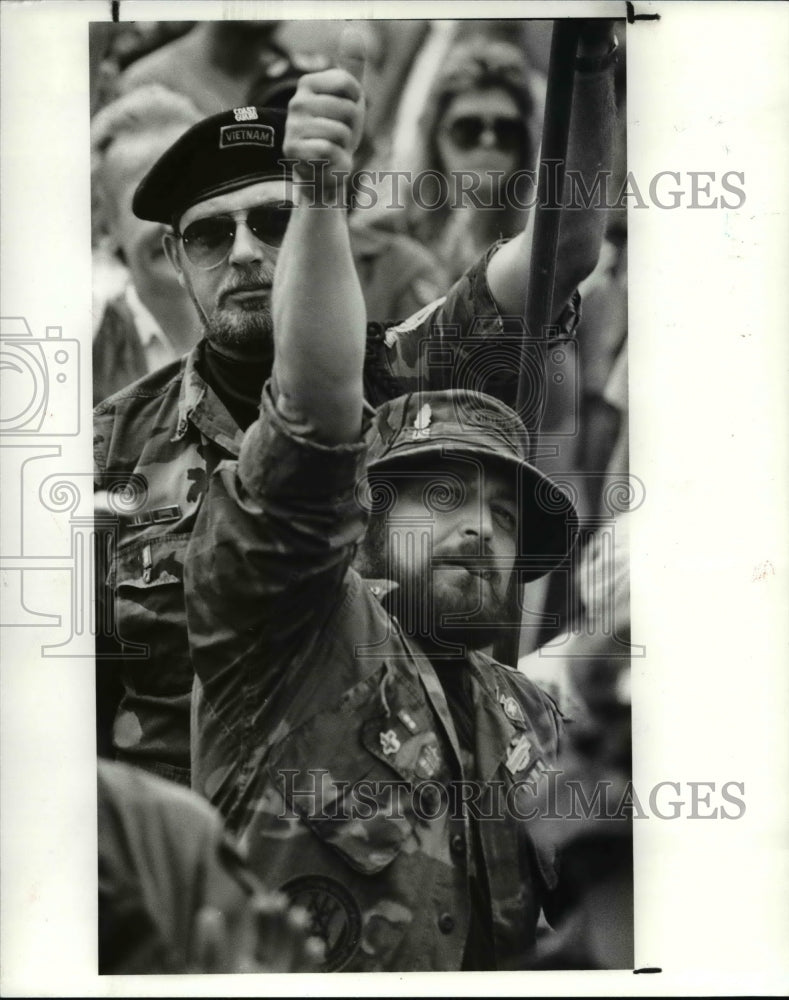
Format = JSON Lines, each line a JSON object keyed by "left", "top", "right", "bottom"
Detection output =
{"left": 282, "top": 875, "right": 362, "bottom": 972}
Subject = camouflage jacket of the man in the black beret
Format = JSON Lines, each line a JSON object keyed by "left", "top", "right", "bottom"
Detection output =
{"left": 94, "top": 248, "right": 578, "bottom": 783}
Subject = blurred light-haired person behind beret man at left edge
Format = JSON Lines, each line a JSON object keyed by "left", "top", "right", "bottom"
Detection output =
{"left": 91, "top": 86, "right": 200, "bottom": 405}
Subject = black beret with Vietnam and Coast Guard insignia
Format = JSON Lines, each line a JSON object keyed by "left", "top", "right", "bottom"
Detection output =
{"left": 132, "top": 106, "right": 292, "bottom": 225}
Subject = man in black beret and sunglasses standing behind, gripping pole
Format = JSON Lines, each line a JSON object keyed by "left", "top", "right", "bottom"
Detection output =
{"left": 94, "top": 23, "right": 613, "bottom": 782}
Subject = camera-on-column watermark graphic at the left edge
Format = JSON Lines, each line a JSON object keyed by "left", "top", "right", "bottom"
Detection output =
{"left": 0, "top": 316, "right": 165, "bottom": 658}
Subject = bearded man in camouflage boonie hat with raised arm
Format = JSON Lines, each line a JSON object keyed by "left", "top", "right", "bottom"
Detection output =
{"left": 185, "top": 35, "right": 576, "bottom": 972}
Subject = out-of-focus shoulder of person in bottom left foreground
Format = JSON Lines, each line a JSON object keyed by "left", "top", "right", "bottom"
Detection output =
{"left": 98, "top": 760, "right": 323, "bottom": 975}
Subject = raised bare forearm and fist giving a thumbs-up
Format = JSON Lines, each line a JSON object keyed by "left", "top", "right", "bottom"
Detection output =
{"left": 272, "top": 30, "right": 367, "bottom": 445}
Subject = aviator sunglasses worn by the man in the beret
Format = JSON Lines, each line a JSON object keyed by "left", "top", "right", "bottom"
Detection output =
{"left": 180, "top": 204, "right": 293, "bottom": 271}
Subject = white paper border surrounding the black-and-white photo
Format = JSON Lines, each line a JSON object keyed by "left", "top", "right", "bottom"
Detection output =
{"left": 0, "top": 0, "right": 789, "bottom": 996}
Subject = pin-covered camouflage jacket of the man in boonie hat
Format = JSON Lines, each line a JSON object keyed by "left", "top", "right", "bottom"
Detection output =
{"left": 186, "top": 384, "right": 561, "bottom": 972}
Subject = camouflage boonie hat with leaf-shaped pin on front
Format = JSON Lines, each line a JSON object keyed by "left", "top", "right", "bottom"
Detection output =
{"left": 366, "top": 389, "right": 578, "bottom": 583}
